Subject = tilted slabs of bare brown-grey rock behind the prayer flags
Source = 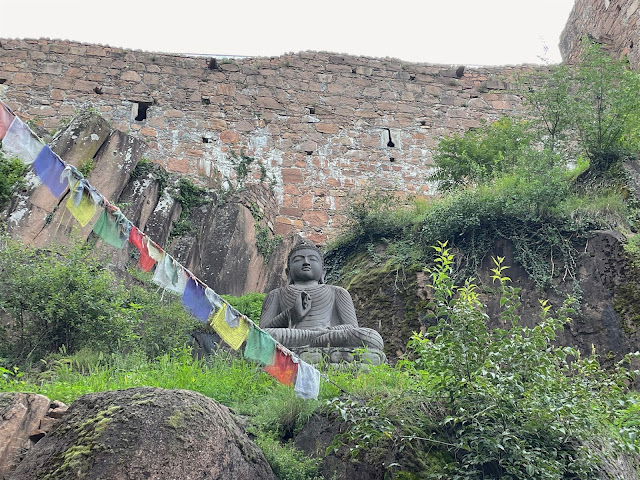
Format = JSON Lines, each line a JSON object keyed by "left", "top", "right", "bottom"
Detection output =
{"left": 3, "top": 113, "right": 293, "bottom": 295}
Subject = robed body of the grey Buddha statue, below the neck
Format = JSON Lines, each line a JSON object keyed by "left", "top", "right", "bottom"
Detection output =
{"left": 260, "top": 284, "right": 384, "bottom": 350}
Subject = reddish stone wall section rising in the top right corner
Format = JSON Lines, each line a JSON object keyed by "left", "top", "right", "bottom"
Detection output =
{"left": 560, "top": 0, "right": 640, "bottom": 68}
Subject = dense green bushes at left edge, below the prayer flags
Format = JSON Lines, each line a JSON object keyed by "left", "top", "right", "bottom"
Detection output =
{"left": 0, "top": 236, "right": 199, "bottom": 364}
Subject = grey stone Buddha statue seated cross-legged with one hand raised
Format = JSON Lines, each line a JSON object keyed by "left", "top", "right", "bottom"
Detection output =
{"left": 260, "top": 241, "right": 384, "bottom": 358}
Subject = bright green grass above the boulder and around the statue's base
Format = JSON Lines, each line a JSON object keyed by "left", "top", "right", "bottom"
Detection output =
{"left": 0, "top": 348, "right": 407, "bottom": 480}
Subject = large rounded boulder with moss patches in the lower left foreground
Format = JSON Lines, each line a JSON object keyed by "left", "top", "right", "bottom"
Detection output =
{"left": 9, "top": 387, "right": 276, "bottom": 480}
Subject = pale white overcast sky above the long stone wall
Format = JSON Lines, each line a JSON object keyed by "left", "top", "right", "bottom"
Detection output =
{"left": 0, "top": 0, "right": 574, "bottom": 65}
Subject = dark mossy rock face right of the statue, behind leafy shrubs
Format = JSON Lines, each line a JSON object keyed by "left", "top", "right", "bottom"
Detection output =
{"left": 340, "top": 231, "right": 640, "bottom": 362}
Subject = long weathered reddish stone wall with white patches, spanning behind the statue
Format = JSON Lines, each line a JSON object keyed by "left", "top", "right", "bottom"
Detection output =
{"left": 0, "top": 39, "right": 532, "bottom": 242}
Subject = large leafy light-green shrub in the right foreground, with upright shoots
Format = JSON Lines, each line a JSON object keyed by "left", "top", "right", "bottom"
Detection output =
{"left": 330, "top": 245, "right": 638, "bottom": 480}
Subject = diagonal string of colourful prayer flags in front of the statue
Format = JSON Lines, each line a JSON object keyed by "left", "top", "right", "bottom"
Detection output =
{"left": 0, "top": 101, "right": 320, "bottom": 399}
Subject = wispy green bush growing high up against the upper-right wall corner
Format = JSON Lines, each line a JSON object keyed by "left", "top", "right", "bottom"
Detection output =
{"left": 520, "top": 39, "right": 640, "bottom": 176}
